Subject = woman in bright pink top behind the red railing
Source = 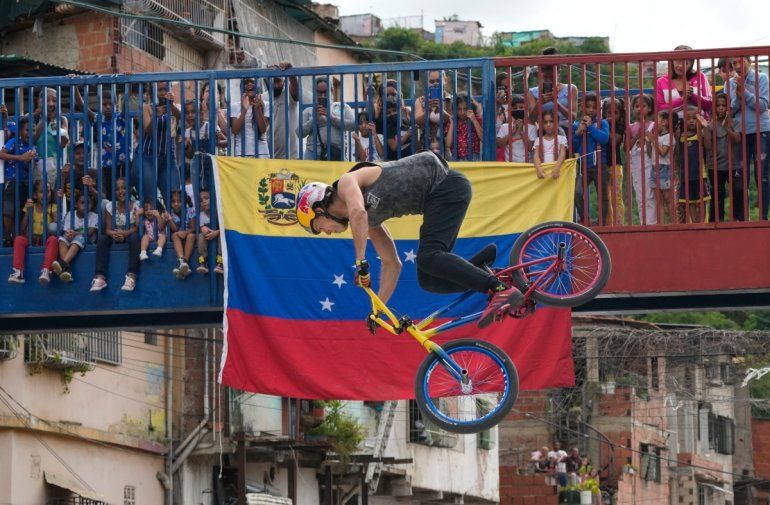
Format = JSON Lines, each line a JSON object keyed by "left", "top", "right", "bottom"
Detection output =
{"left": 655, "top": 46, "right": 712, "bottom": 118}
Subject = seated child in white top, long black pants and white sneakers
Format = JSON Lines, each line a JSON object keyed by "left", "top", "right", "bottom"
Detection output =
{"left": 91, "top": 178, "right": 140, "bottom": 292}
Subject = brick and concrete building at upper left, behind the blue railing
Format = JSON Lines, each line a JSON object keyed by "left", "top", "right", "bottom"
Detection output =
{"left": 0, "top": 0, "right": 368, "bottom": 77}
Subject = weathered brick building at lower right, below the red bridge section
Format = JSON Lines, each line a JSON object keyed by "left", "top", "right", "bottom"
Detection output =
{"left": 492, "top": 318, "right": 756, "bottom": 505}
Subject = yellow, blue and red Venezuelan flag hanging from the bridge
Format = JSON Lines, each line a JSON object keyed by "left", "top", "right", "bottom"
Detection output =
{"left": 214, "top": 157, "right": 575, "bottom": 400}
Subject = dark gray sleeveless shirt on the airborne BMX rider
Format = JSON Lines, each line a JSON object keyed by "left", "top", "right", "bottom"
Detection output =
{"left": 352, "top": 151, "right": 449, "bottom": 226}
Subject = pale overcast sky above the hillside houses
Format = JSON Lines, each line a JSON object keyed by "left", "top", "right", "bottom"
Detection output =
{"left": 326, "top": 0, "right": 770, "bottom": 53}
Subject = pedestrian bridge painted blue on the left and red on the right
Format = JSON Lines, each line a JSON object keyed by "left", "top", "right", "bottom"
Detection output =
{"left": 0, "top": 47, "right": 770, "bottom": 332}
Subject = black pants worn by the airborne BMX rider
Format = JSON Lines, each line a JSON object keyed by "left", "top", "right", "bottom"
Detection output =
{"left": 417, "top": 170, "right": 500, "bottom": 293}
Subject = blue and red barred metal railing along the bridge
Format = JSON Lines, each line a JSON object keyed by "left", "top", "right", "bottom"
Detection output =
{"left": 0, "top": 47, "right": 770, "bottom": 256}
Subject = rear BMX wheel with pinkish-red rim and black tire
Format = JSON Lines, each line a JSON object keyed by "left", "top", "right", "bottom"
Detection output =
{"left": 510, "top": 221, "right": 612, "bottom": 307}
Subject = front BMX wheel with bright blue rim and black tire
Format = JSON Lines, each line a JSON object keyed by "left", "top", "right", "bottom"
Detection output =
{"left": 414, "top": 339, "right": 519, "bottom": 434}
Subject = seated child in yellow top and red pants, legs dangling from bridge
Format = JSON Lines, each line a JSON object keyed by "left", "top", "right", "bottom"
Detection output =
{"left": 8, "top": 181, "right": 58, "bottom": 285}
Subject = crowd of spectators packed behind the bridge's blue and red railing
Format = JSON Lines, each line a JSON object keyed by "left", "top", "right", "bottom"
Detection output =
{"left": 0, "top": 50, "right": 770, "bottom": 291}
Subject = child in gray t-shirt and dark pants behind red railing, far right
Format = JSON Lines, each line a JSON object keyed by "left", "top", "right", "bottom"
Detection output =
{"left": 703, "top": 92, "right": 743, "bottom": 221}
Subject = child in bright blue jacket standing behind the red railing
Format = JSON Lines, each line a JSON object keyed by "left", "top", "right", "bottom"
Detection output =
{"left": 572, "top": 93, "right": 610, "bottom": 224}
